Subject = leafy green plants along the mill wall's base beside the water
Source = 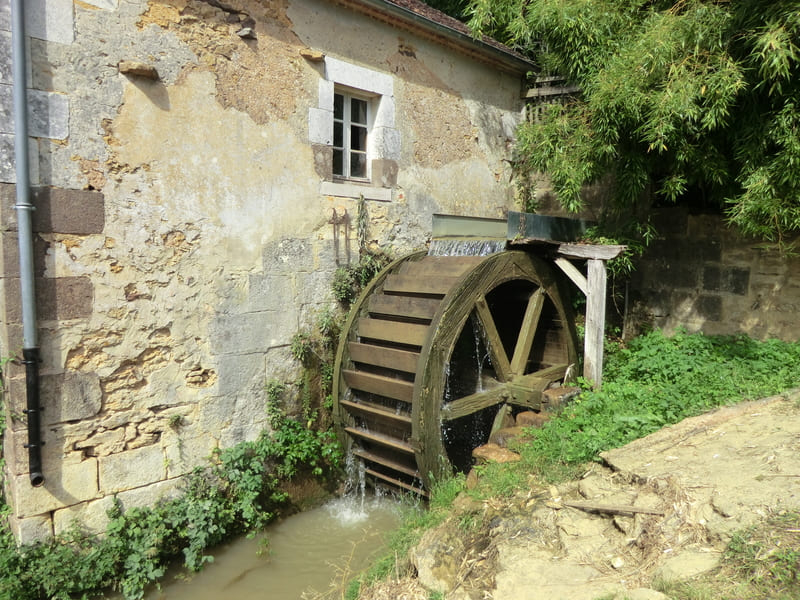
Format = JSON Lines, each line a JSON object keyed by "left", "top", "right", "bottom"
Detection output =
{"left": 0, "top": 398, "right": 341, "bottom": 600}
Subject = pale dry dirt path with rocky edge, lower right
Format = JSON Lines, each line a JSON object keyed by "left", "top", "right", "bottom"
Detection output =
{"left": 362, "top": 390, "right": 800, "bottom": 600}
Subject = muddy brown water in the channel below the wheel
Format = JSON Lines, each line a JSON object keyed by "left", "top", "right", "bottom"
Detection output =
{"left": 133, "top": 497, "right": 401, "bottom": 600}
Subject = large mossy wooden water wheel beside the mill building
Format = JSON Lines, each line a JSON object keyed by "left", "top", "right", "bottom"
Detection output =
{"left": 333, "top": 251, "right": 577, "bottom": 495}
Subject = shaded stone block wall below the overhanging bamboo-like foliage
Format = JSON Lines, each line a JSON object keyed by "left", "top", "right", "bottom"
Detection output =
{"left": 628, "top": 208, "right": 800, "bottom": 341}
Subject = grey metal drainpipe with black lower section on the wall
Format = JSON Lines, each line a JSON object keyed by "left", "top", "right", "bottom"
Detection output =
{"left": 11, "top": 0, "right": 44, "bottom": 486}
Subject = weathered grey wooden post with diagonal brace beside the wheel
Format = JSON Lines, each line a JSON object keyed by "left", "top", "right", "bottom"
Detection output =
{"left": 555, "top": 244, "right": 626, "bottom": 389}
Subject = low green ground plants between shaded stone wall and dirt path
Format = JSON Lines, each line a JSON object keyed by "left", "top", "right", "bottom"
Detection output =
{"left": 522, "top": 331, "right": 800, "bottom": 474}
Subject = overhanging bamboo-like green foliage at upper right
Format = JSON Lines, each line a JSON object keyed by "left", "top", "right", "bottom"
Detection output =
{"left": 470, "top": 0, "right": 800, "bottom": 244}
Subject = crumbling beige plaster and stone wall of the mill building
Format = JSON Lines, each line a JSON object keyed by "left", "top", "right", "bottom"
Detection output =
{"left": 0, "top": 0, "right": 520, "bottom": 541}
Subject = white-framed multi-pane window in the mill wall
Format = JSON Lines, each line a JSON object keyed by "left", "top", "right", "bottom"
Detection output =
{"left": 333, "top": 92, "right": 369, "bottom": 179}
